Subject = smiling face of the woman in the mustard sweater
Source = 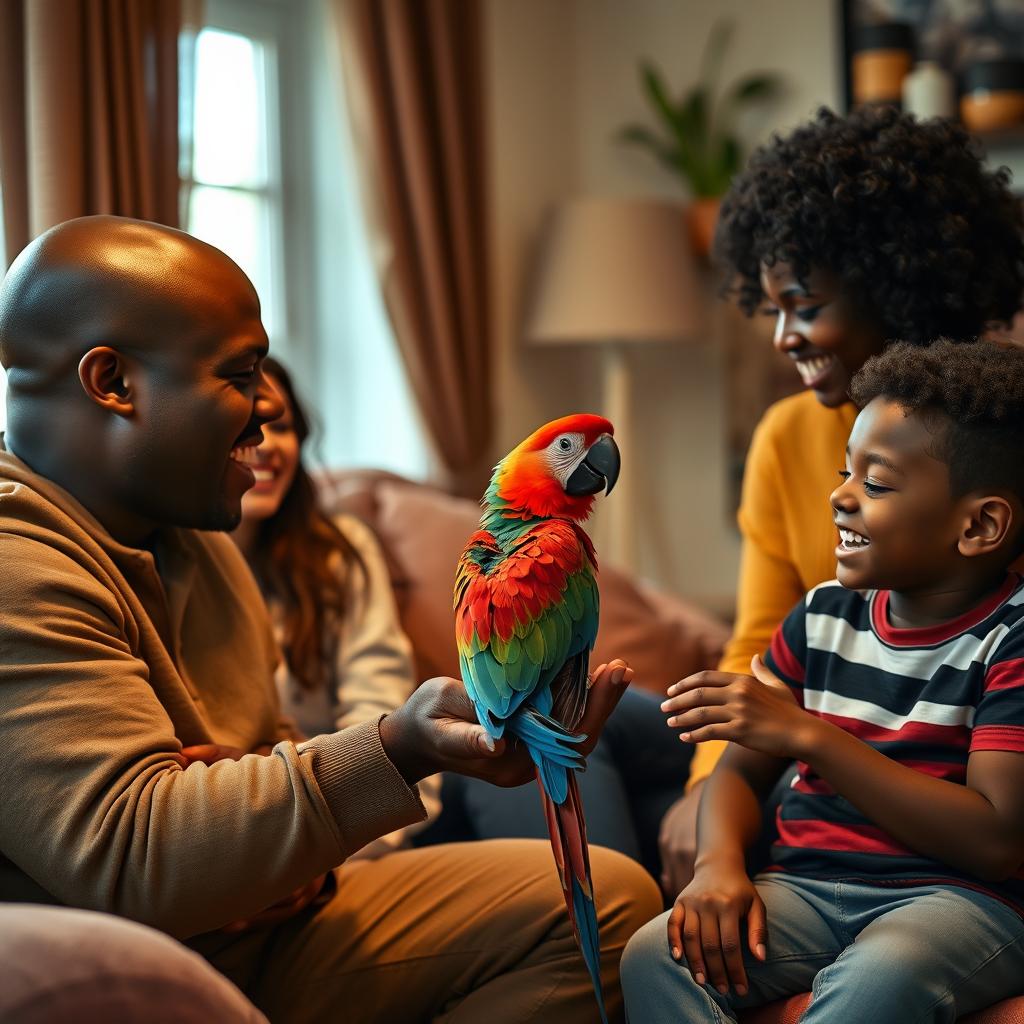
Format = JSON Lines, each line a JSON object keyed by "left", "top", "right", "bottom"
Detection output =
{"left": 761, "top": 262, "right": 885, "bottom": 409}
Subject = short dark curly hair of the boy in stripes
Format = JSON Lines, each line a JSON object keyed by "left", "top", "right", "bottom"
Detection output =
{"left": 850, "top": 338, "right": 1024, "bottom": 507}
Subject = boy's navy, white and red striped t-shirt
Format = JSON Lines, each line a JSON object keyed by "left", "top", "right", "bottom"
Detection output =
{"left": 765, "top": 573, "right": 1024, "bottom": 911}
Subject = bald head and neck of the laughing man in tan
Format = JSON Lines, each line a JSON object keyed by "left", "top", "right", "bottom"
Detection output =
{"left": 0, "top": 217, "right": 281, "bottom": 544}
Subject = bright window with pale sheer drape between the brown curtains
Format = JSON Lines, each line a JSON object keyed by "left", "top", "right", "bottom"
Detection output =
{"left": 180, "top": 0, "right": 430, "bottom": 478}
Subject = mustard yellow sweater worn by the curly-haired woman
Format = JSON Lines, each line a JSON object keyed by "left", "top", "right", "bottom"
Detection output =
{"left": 689, "top": 391, "right": 857, "bottom": 785}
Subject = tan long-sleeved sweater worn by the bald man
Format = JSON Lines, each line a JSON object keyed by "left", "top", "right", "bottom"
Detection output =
{"left": 0, "top": 450, "right": 424, "bottom": 938}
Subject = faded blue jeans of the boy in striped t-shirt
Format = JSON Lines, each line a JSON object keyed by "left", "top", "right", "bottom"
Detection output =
{"left": 622, "top": 873, "right": 1024, "bottom": 1024}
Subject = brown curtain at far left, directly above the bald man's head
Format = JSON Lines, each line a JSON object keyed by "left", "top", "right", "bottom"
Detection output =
{"left": 0, "top": 0, "right": 181, "bottom": 263}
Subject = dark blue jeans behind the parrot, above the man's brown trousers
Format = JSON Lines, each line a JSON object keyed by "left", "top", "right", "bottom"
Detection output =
{"left": 415, "top": 689, "right": 693, "bottom": 878}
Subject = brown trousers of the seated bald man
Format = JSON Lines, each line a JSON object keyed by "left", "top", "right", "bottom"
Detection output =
{"left": 189, "top": 840, "right": 662, "bottom": 1024}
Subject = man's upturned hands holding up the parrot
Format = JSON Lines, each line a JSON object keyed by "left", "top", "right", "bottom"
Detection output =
{"left": 380, "top": 658, "right": 633, "bottom": 786}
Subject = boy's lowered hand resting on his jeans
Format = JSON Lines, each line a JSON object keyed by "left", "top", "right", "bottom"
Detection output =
{"left": 669, "top": 858, "right": 768, "bottom": 995}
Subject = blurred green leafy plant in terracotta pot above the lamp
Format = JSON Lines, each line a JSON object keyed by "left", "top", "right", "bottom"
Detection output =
{"left": 618, "top": 22, "right": 782, "bottom": 255}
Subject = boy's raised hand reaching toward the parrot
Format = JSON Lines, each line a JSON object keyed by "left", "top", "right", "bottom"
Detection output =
{"left": 662, "top": 655, "right": 819, "bottom": 760}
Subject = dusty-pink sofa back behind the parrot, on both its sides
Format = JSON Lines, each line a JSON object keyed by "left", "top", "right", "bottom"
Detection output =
{"left": 318, "top": 470, "right": 729, "bottom": 693}
